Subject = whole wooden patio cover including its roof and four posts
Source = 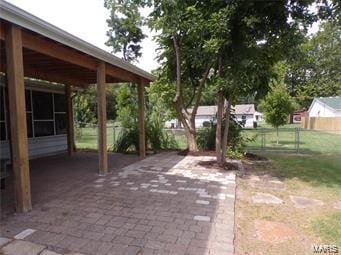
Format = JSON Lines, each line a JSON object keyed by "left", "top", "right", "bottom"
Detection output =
{"left": 0, "top": 2, "right": 153, "bottom": 212}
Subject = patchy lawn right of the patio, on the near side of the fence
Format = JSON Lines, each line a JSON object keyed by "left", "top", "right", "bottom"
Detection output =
{"left": 236, "top": 153, "right": 341, "bottom": 255}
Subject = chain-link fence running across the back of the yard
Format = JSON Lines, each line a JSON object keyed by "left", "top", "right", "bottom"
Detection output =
{"left": 75, "top": 123, "right": 341, "bottom": 154}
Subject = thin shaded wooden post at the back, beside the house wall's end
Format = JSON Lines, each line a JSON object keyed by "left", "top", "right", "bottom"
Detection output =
{"left": 65, "top": 85, "right": 74, "bottom": 156}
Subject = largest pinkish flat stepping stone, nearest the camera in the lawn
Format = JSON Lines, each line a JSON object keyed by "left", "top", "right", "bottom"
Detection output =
{"left": 255, "top": 220, "right": 296, "bottom": 243}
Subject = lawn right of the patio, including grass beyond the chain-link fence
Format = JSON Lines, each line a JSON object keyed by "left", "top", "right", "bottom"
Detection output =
{"left": 236, "top": 125, "right": 341, "bottom": 254}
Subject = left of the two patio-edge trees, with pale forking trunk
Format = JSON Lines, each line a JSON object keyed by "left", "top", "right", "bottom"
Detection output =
{"left": 149, "top": 0, "right": 214, "bottom": 151}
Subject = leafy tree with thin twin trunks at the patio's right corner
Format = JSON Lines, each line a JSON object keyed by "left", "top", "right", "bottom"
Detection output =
{"left": 202, "top": 0, "right": 322, "bottom": 164}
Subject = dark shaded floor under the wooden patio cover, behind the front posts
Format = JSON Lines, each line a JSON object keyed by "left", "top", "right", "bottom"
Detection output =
{"left": 0, "top": 152, "right": 140, "bottom": 213}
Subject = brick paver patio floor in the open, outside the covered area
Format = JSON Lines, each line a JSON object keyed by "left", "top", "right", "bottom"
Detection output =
{"left": 0, "top": 152, "right": 235, "bottom": 255}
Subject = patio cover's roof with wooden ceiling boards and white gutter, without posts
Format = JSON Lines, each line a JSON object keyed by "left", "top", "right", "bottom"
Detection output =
{"left": 0, "top": 0, "right": 154, "bottom": 86}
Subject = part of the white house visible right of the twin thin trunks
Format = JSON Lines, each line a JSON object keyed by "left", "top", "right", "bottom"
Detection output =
{"left": 232, "top": 104, "right": 256, "bottom": 127}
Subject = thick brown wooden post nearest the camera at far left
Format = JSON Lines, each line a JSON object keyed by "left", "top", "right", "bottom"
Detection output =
{"left": 5, "top": 25, "right": 32, "bottom": 212}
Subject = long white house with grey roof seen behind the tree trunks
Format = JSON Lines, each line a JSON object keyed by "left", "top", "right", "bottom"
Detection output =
{"left": 165, "top": 104, "right": 263, "bottom": 128}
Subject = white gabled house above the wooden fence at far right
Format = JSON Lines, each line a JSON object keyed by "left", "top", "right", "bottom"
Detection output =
{"left": 308, "top": 96, "right": 341, "bottom": 117}
